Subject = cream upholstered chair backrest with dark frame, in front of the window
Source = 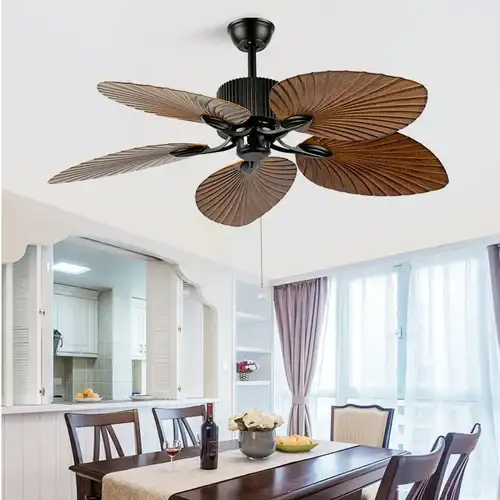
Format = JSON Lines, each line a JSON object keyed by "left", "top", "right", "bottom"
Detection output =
{"left": 330, "top": 404, "right": 394, "bottom": 448}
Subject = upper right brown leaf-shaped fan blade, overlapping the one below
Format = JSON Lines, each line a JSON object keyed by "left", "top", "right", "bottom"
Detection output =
{"left": 269, "top": 71, "right": 427, "bottom": 141}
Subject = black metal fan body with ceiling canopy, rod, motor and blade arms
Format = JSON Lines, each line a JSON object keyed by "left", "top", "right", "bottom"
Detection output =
{"left": 212, "top": 17, "right": 332, "bottom": 162}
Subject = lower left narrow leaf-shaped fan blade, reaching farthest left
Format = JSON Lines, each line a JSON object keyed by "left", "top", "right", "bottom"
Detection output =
{"left": 49, "top": 143, "right": 208, "bottom": 184}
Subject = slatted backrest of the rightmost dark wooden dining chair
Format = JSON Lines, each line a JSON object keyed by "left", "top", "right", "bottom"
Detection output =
{"left": 425, "top": 424, "right": 481, "bottom": 500}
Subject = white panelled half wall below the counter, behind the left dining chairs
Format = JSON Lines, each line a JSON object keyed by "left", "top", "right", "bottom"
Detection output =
{"left": 1, "top": 399, "right": 213, "bottom": 500}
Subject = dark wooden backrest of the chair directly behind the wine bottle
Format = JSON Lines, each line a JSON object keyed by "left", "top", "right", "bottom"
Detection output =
{"left": 153, "top": 405, "right": 205, "bottom": 450}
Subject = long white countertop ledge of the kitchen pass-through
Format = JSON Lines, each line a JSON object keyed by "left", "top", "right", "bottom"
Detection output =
{"left": 0, "top": 398, "right": 217, "bottom": 415}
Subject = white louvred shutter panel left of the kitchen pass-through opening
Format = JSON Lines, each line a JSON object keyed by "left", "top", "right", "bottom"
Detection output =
{"left": 2, "top": 245, "right": 53, "bottom": 406}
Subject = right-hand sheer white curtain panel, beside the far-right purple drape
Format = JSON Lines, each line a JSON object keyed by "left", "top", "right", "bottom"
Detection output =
{"left": 404, "top": 249, "right": 500, "bottom": 500}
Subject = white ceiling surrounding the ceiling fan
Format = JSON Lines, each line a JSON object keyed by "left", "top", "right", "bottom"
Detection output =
{"left": 2, "top": 0, "right": 500, "bottom": 278}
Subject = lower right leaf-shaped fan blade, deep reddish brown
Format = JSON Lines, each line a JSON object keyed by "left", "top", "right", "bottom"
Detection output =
{"left": 296, "top": 133, "right": 448, "bottom": 196}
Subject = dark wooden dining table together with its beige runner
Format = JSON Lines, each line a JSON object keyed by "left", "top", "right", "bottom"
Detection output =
{"left": 70, "top": 440, "right": 405, "bottom": 500}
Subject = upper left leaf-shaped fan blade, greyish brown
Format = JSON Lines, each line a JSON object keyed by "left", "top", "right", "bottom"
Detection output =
{"left": 97, "top": 82, "right": 251, "bottom": 125}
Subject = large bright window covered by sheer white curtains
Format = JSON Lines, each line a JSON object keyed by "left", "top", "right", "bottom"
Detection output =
{"left": 275, "top": 250, "right": 500, "bottom": 500}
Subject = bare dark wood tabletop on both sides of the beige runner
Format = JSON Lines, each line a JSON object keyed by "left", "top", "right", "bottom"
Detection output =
{"left": 70, "top": 441, "right": 404, "bottom": 500}
